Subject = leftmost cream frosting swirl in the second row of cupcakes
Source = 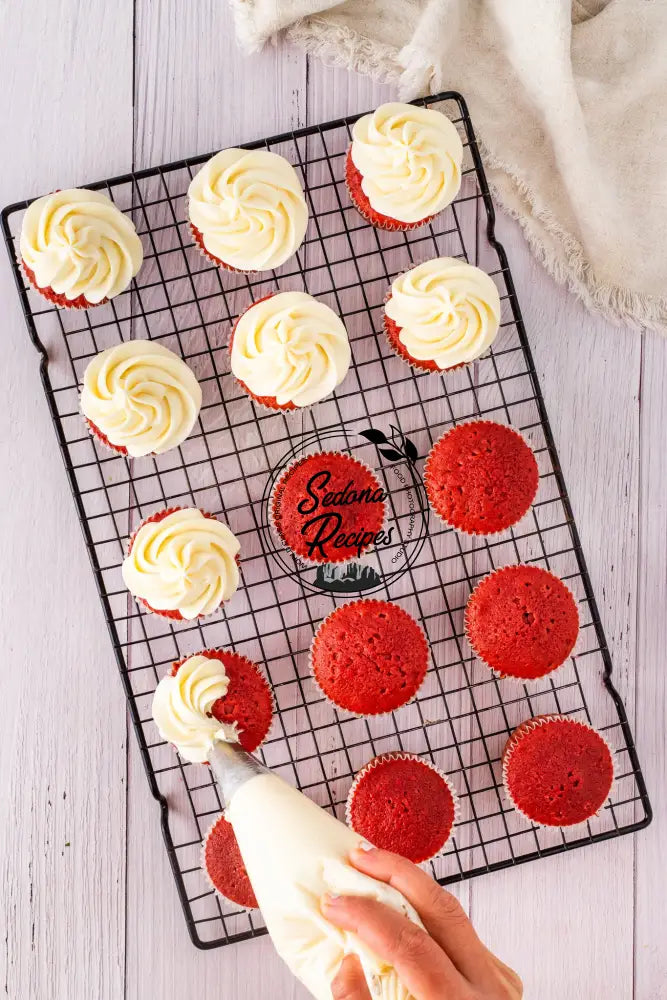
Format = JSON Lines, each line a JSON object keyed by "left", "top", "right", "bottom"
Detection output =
{"left": 81, "top": 340, "right": 201, "bottom": 458}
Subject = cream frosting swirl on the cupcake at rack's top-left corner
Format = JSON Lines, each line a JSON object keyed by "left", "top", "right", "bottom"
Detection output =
{"left": 20, "top": 188, "right": 143, "bottom": 305}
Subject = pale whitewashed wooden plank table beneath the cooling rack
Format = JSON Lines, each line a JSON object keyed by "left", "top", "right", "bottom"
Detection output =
{"left": 0, "top": 7, "right": 667, "bottom": 1000}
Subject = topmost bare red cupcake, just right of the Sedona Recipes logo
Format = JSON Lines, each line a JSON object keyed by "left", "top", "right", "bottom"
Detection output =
{"left": 424, "top": 420, "right": 539, "bottom": 535}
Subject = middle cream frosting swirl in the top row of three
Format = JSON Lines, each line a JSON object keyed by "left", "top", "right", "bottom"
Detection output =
{"left": 188, "top": 149, "right": 308, "bottom": 271}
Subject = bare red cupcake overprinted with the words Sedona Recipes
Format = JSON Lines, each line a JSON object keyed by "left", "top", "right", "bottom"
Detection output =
{"left": 271, "top": 451, "right": 391, "bottom": 564}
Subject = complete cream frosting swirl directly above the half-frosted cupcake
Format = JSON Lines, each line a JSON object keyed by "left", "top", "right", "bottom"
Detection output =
{"left": 122, "top": 507, "right": 240, "bottom": 620}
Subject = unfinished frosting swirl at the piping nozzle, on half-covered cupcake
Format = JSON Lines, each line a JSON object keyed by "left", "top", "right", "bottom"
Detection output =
{"left": 152, "top": 653, "right": 239, "bottom": 764}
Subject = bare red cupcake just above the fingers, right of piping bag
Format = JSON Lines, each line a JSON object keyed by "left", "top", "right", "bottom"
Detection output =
{"left": 346, "top": 753, "right": 457, "bottom": 864}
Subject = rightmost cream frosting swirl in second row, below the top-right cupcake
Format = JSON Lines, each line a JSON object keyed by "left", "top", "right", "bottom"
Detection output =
{"left": 385, "top": 257, "right": 500, "bottom": 370}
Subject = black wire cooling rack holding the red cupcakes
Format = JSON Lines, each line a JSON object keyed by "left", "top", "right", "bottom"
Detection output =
{"left": 2, "top": 93, "right": 651, "bottom": 948}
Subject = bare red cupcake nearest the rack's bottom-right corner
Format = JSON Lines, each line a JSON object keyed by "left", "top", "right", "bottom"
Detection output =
{"left": 503, "top": 715, "right": 614, "bottom": 826}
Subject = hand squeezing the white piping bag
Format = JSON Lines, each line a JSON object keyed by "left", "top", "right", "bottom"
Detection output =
{"left": 322, "top": 848, "right": 523, "bottom": 1000}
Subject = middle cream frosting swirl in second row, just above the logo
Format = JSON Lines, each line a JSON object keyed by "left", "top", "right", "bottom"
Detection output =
{"left": 231, "top": 292, "right": 350, "bottom": 406}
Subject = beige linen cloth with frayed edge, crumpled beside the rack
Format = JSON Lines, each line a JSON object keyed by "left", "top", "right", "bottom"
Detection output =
{"left": 231, "top": 0, "right": 667, "bottom": 334}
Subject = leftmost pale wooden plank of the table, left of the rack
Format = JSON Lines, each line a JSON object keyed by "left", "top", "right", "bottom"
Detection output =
{"left": 0, "top": 0, "right": 133, "bottom": 1000}
